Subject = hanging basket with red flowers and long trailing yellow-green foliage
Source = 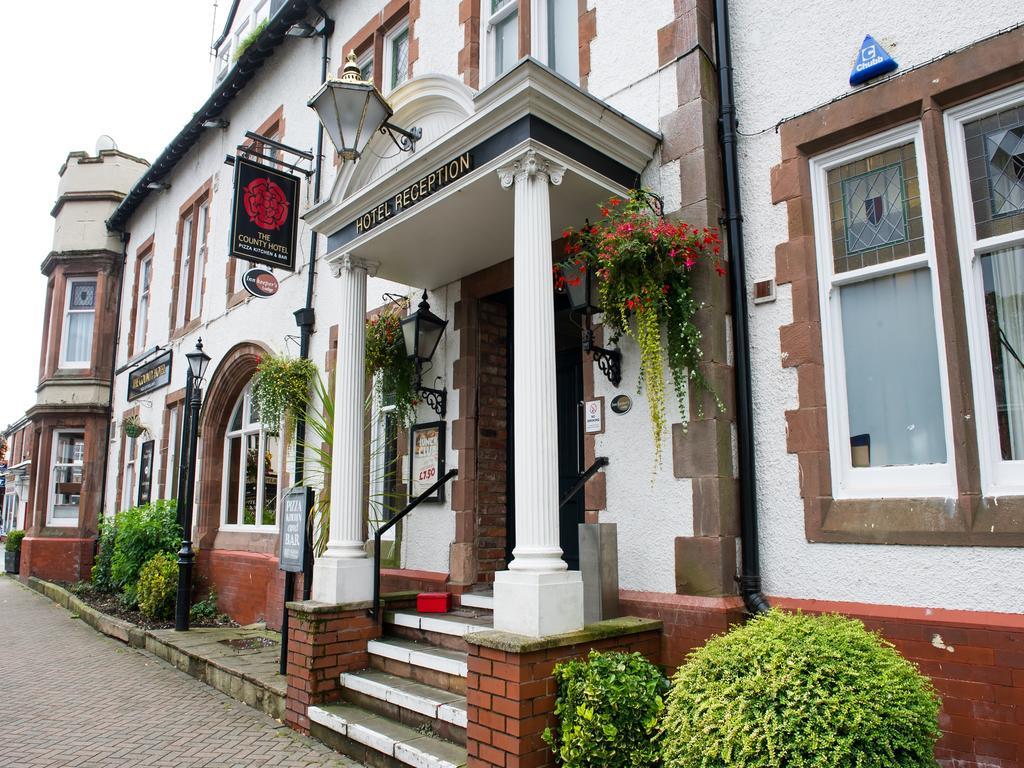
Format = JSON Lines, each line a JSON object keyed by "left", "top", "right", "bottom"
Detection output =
{"left": 555, "top": 189, "right": 725, "bottom": 465}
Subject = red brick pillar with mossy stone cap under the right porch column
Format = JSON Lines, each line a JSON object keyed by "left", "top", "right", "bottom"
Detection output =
{"left": 466, "top": 616, "right": 662, "bottom": 768}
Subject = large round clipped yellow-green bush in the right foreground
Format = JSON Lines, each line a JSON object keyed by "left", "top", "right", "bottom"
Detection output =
{"left": 664, "top": 610, "right": 939, "bottom": 768}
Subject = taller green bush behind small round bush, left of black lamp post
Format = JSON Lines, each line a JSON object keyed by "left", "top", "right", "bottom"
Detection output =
{"left": 111, "top": 500, "right": 181, "bottom": 599}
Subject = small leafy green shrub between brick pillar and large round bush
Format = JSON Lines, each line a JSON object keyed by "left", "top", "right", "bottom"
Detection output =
{"left": 544, "top": 650, "right": 669, "bottom": 768}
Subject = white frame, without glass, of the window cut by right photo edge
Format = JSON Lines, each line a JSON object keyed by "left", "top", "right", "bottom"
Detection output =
{"left": 943, "top": 84, "right": 1024, "bottom": 497}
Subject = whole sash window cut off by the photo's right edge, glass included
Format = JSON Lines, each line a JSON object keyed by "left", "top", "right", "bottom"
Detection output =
{"left": 945, "top": 86, "right": 1024, "bottom": 496}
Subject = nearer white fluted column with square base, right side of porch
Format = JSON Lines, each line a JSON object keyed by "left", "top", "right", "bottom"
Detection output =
{"left": 495, "top": 150, "right": 583, "bottom": 637}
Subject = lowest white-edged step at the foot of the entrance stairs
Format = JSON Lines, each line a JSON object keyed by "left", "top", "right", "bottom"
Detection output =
{"left": 308, "top": 705, "right": 466, "bottom": 768}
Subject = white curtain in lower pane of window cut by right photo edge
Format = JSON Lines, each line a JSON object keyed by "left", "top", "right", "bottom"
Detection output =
{"left": 989, "top": 246, "right": 1024, "bottom": 459}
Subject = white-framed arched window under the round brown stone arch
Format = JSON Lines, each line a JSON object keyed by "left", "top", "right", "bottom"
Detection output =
{"left": 220, "top": 385, "right": 281, "bottom": 528}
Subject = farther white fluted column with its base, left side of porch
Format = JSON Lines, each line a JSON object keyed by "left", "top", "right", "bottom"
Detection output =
{"left": 312, "top": 254, "right": 374, "bottom": 603}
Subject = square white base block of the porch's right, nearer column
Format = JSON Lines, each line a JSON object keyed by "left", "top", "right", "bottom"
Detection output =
{"left": 495, "top": 570, "right": 583, "bottom": 637}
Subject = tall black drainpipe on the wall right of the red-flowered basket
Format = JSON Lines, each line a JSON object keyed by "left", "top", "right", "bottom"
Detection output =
{"left": 715, "top": 0, "right": 771, "bottom": 614}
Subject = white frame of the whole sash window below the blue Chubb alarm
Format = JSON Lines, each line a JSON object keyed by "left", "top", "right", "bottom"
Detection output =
{"left": 810, "top": 123, "right": 956, "bottom": 499}
